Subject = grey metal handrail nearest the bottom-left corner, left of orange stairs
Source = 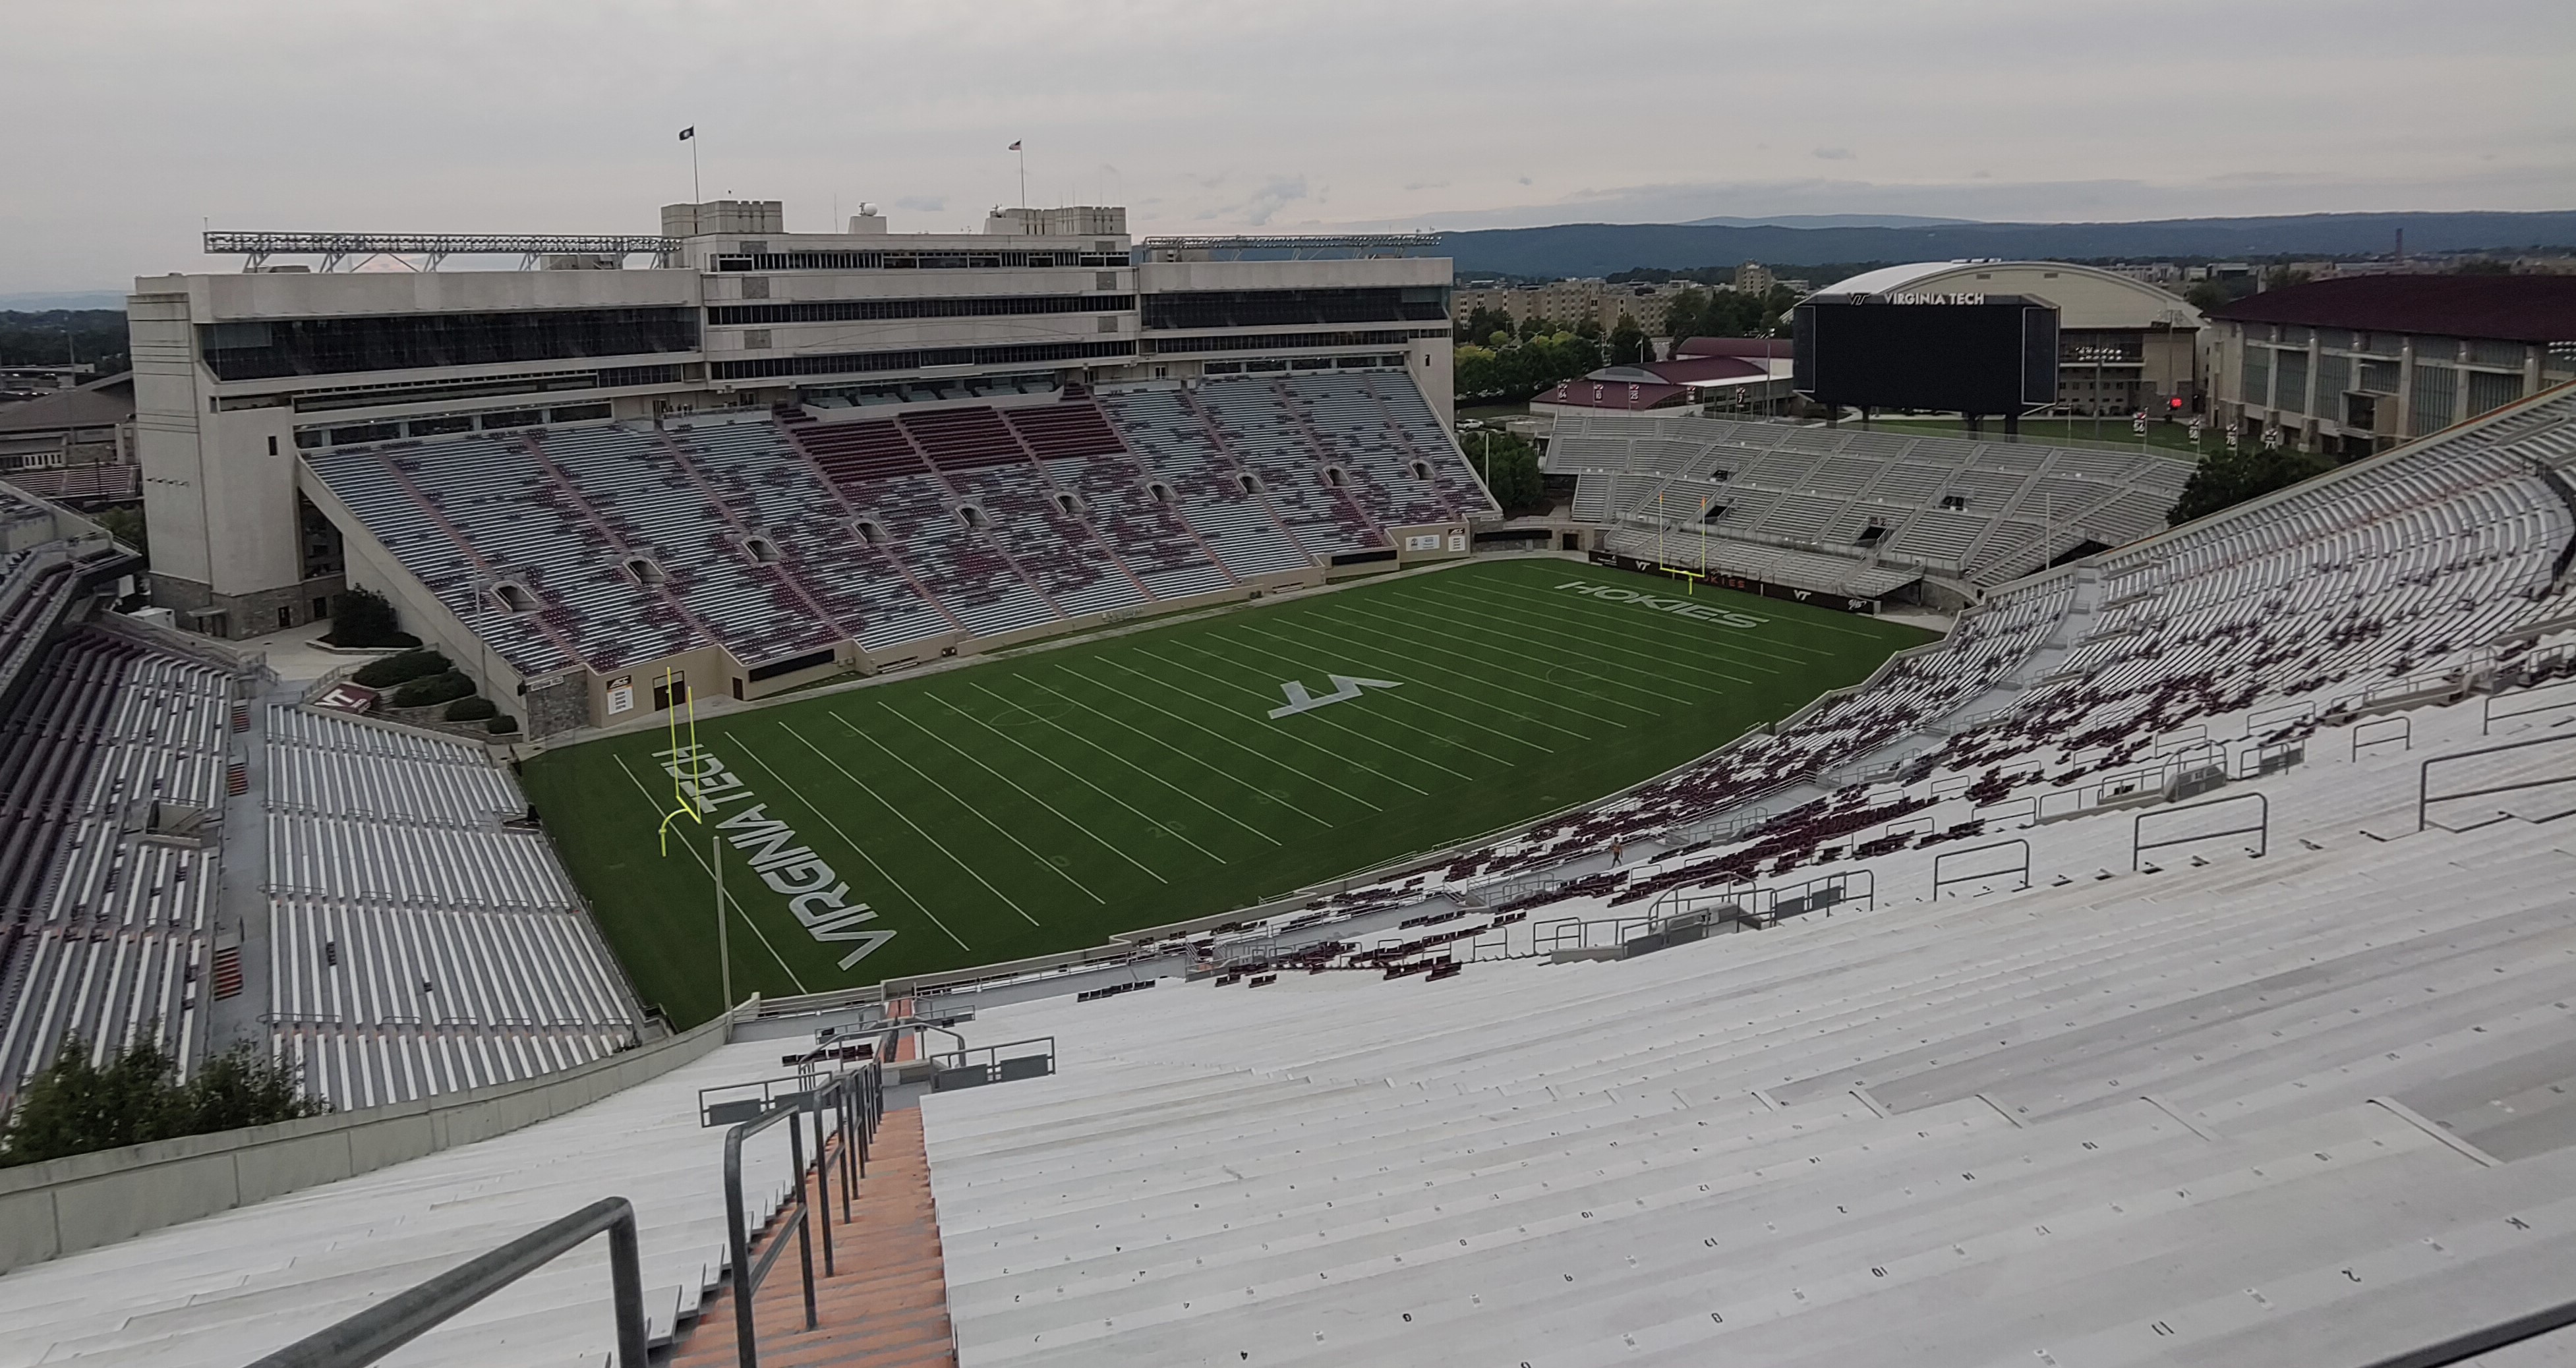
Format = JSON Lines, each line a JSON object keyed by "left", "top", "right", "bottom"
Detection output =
{"left": 250, "top": 1198, "right": 647, "bottom": 1368}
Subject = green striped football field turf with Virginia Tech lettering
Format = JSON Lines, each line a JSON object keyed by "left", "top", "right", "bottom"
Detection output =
{"left": 525, "top": 559, "right": 1927, "bottom": 1023}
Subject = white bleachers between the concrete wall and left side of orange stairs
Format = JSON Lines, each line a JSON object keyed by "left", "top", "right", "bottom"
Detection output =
{"left": 0, "top": 1043, "right": 804, "bottom": 1368}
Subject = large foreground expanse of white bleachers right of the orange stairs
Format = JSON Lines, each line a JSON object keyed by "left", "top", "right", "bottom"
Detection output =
{"left": 925, "top": 737, "right": 2576, "bottom": 1368}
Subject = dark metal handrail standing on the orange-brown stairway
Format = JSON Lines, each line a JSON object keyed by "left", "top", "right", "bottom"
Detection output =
{"left": 724, "top": 1059, "right": 883, "bottom": 1368}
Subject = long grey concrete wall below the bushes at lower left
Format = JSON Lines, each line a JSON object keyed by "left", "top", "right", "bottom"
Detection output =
{"left": 0, "top": 1017, "right": 732, "bottom": 1272}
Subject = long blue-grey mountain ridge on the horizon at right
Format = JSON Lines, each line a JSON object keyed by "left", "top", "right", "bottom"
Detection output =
{"left": 1445, "top": 212, "right": 2576, "bottom": 283}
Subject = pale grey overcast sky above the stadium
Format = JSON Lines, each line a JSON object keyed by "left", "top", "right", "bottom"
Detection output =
{"left": 0, "top": 0, "right": 2576, "bottom": 291}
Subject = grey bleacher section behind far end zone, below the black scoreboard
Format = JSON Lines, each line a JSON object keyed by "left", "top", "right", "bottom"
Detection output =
{"left": 1548, "top": 414, "right": 2192, "bottom": 583}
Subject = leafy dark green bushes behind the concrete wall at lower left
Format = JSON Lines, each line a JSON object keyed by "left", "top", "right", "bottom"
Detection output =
{"left": 0, "top": 1039, "right": 324, "bottom": 1167}
